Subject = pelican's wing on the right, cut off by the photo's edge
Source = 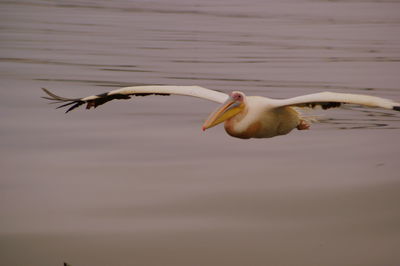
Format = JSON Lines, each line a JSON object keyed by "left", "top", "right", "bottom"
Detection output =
{"left": 273, "top": 92, "right": 400, "bottom": 111}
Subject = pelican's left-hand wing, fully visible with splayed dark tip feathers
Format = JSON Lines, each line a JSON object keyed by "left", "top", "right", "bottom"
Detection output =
{"left": 42, "top": 86, "right": 229, "bottom": 113}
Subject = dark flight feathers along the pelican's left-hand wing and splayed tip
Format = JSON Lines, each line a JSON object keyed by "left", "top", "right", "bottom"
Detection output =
{"left": 42, "top": 88, "right": 170, "bottom": 113}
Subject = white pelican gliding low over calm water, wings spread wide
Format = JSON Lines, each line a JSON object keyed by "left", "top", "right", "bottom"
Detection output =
{"left": 42, "top": 86, "right": 400, "bottom": 139}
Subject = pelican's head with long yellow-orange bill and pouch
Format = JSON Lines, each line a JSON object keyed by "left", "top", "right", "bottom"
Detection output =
{"left": 203, "top": 91, "right": 246, "bottom": 131}
